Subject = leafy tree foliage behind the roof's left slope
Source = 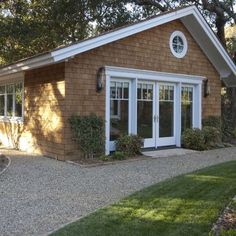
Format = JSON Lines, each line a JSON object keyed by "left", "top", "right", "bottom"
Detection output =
{"left": 0, "top": 0, "right": 137, "bottom": 64}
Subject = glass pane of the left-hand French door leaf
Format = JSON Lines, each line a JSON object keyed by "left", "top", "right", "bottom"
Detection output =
{"left": 137, "top": 83, "right": 153, "bottom": 138}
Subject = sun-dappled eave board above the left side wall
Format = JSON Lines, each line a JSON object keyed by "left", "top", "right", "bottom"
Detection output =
{"left": 0, "top": 53, "right": 54, "bottom": 76}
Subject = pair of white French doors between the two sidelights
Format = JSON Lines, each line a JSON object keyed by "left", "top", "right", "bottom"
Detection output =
{"left": 137, "top": 81, "right": 176, "bottom": 148}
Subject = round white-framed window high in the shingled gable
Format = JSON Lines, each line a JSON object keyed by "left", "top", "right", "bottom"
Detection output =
{"left": 170, "top": 31, "right": 188, "bottom": 58}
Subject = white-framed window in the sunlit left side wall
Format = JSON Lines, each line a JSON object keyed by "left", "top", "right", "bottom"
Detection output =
{"left": 0, "top": 82, "right": 24, "bottom": 119}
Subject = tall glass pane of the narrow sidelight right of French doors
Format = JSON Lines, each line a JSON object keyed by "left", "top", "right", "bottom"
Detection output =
{"left": 181, "top": 87, "right": 193, "bottom": 132}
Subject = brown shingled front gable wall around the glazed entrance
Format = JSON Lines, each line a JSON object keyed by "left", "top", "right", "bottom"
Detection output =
{"left": 65, "top": 20, "right": 221, "bottom": 158}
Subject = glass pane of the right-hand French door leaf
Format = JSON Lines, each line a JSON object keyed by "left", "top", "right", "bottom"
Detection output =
{"left": 159, "top": 85, "right": 174, "bottom": 138}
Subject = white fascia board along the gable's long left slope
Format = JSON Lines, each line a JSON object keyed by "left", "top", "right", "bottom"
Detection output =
{"left": 51, "top": 6, "right": 196, "bottom": 61}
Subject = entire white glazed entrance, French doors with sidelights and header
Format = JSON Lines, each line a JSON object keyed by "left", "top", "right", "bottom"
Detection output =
{"left": 105, "top": 67, "right": 205, "bottom": 154}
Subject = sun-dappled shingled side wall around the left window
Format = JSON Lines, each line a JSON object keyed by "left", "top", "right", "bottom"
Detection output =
{"left": 0, "top": 63, "right": 65, "bottom": 159}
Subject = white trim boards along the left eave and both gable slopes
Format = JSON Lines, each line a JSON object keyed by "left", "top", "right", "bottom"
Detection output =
{"left": 0, "top": 6, "right": 236, "bottom": 85}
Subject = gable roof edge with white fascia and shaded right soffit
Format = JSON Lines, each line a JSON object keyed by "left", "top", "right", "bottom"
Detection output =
{"left": 0, "top": 6, "right": 236, "bottom": 87}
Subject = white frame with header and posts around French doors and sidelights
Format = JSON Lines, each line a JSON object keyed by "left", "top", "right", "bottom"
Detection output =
{"left": 105, "top": 66, "right": 205, "bottom": 154}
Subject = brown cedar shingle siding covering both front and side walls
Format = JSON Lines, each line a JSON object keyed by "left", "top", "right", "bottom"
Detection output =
{"left": 1, "top": 20, "right": 221, "bottom": 160}
